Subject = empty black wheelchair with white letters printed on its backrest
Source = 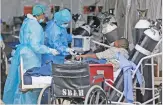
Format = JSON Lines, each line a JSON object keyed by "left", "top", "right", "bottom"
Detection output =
{"left": 38, "top": 63, "right": 108, "bottom": 105}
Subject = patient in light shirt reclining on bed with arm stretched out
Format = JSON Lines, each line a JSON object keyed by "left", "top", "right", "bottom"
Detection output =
{"left": 76, "top": 38, "right": 129, "bottom": 71}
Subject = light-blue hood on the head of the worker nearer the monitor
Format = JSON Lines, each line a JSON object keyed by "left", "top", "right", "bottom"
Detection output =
{"left": 54, "top": 9, "right": 72, "bottom": 26}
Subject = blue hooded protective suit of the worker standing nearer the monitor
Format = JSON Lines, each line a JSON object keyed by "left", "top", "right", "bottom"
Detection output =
{"left": 42, "top": 9, "right": 72, "bottom": 64}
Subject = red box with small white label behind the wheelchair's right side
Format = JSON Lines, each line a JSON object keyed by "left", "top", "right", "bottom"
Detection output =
{"left": 89, "top": 64, "right": 113, "bottom": 84}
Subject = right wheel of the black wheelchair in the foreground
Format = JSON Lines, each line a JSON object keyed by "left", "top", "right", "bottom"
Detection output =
{"left": 84, "top": 85, "right": 108, "bottom": 105}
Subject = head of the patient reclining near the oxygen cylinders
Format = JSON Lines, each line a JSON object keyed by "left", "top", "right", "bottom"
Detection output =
{"left": 114, "top": 38, "right": 129, "bottom": 50}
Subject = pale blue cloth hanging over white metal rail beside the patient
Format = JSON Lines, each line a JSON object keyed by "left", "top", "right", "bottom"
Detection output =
{"left": 116, "top": 53, "right": 143, "bottom": 103}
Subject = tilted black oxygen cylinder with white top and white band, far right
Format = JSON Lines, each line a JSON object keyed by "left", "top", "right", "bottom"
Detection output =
{"left": 131, "top": 28, "right": 160, "bottom": 64}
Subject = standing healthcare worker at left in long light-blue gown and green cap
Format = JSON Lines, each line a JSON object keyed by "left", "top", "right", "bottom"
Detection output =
{"left": 3, "top": 5, "right": 58, "bottom": 104}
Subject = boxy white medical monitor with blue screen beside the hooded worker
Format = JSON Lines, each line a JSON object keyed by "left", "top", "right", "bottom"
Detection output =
{"left": 72, "top": 35, "right": 90, "bottom": 52}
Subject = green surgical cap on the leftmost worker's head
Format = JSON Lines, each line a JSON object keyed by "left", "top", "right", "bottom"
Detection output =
{"left": 32, "top": 4, "right": 45, "bottom": 16}
